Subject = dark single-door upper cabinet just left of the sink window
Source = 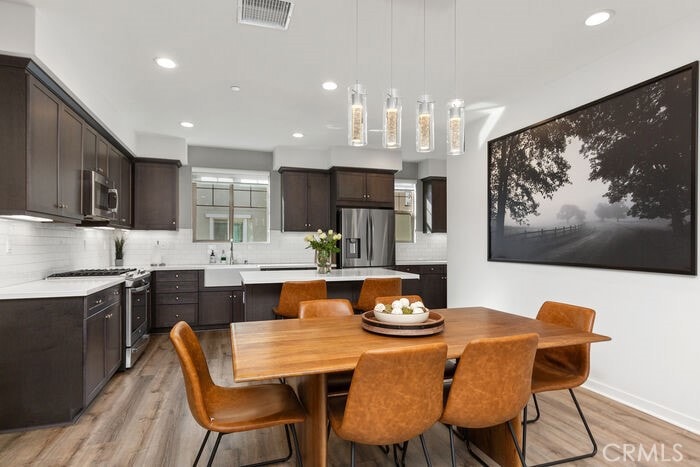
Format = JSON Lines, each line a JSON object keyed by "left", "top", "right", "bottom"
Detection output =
{"left": 134, "top": 159, "right": 181, "bottom": 230}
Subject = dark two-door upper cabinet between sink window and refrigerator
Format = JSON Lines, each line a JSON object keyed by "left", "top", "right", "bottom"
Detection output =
{"left": 280, "top": 168, "right": 330, "bottom": 232}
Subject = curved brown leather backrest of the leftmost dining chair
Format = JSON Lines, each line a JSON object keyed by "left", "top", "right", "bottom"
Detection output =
{"left": 170, "top": 321, "right": 214, "bottom": 429}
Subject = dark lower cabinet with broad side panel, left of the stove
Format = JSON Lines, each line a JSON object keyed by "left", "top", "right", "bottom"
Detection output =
{"left": 0, "top": 285, "right": 123, "bottom": 432}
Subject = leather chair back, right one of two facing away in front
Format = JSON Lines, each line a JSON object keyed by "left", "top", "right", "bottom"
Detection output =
{"left": 441, "top": 334, "right": 538, "bottom": 428}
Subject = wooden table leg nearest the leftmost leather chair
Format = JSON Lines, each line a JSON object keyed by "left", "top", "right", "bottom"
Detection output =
{"left": 289, "top": 374, "right": 328, "bottom": 467}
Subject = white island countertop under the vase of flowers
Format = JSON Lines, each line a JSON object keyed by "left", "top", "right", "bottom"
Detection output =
{"left": 241, "top": 268, "right": 420, "bottom": 285}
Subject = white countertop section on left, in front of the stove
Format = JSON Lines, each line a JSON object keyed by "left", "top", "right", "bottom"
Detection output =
{"left": 0, "top": 277, "right": 124, "bottom": 300}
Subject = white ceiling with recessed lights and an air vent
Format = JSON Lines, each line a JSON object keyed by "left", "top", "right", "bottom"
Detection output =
{"left": 15, "top": 0, "right": 700, "bottom": 161}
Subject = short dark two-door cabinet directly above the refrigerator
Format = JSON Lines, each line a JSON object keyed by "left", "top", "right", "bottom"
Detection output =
{"left": 331, "top": 168, "right": 394, "bottom": 208}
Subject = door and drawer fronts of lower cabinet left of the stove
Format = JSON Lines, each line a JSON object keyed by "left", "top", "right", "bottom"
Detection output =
{"left": 84, "top": 285, "right": 123, "bottom": 406}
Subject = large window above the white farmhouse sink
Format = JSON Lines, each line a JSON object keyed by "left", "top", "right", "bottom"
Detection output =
{"left": 192, "top": 168, "right": 270, "bottom": 243}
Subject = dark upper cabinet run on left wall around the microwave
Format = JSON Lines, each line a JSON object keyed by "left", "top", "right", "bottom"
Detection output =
{"left": 0, "top": 55, "right": 136, "bottom": 223}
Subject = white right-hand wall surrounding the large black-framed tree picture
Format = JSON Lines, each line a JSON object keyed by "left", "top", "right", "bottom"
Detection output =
{"left": 447, "top": 18, "right": 700, "bottom": 433}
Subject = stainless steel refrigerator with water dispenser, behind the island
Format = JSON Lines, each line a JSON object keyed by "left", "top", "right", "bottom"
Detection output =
{"left": 338, "top": 208, "right": 396, "bottom": 268}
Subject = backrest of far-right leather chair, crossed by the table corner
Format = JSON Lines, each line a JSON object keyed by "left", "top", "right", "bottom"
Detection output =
{"left": 535, "top": 302, "right": 595, "bottom": 384}
